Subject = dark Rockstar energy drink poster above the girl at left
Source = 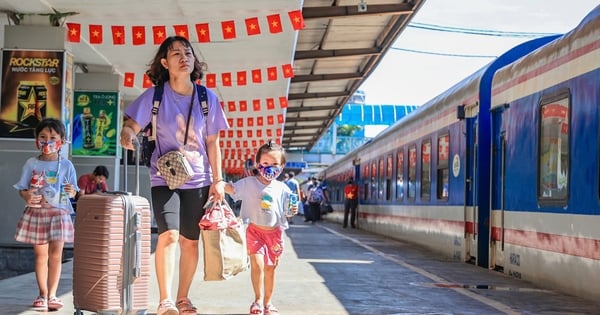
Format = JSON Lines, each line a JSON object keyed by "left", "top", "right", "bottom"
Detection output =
{"left": 0, "top": 50, "right": 65, "bottom": 138}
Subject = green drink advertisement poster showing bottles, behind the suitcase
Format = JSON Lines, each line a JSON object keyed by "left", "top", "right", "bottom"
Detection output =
{"left": 72, "top": 91, "right": 119, "bottom": 156}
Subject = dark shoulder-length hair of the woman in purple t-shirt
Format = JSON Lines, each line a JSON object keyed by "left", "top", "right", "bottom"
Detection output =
{"left": 146, "top": 36, "right": 206, "bottom": 85}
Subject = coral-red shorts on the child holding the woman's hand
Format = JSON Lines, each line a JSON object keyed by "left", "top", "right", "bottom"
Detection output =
{"left": 246, "top": 224, "right": 283, "bottom": 266}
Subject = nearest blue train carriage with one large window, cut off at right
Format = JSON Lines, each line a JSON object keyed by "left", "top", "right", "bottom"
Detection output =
{"left": 490, "top": 6, "right": 600, "bottom": 299}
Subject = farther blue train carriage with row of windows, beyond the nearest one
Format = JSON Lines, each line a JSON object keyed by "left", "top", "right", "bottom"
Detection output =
{"left": 324, "top": 31, "right": 557, "bottom": 268}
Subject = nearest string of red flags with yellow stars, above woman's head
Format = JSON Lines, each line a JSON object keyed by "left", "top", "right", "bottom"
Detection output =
{"left": 66, "top": 10, "right": 305, "bottom": 46}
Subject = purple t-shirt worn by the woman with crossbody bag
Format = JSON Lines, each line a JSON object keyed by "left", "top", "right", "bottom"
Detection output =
{"left": 125, "top": 82, "right": 229, "bottom": 189}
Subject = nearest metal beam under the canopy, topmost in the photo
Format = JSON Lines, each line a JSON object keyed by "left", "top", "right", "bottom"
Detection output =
{"left": 302, "top": 3, "right": 414, "bottom": 20}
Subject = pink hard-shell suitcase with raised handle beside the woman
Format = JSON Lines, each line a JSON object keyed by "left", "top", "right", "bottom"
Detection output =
{"left": 73, "top": 150, "right": 152, "bottom": 315}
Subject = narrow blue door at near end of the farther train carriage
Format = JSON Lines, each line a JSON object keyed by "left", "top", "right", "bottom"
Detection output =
{"left": 463, "top": 118, "right": 477, "bottom": 264}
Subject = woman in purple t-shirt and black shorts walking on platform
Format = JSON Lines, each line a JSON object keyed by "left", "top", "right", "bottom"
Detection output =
{"left": 121, "top": 36, "right": 228, "bottom": 315}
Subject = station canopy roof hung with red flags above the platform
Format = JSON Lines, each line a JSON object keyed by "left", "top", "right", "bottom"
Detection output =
{"left": 0, "top": 0, "right": 425, "bottom": 173}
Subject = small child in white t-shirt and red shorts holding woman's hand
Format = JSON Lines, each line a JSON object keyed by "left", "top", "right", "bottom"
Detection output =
{"left": 225, "top": 141, "right": 298, "bottom": 315}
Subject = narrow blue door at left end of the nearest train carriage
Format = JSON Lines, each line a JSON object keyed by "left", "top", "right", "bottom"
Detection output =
{"left": 490, "top": 107, "right": 506, "bottom": 270}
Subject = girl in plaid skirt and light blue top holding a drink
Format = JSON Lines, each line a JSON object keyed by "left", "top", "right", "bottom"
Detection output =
{"left": 13, "top": 118, "right": 79, "bottom": 312}
